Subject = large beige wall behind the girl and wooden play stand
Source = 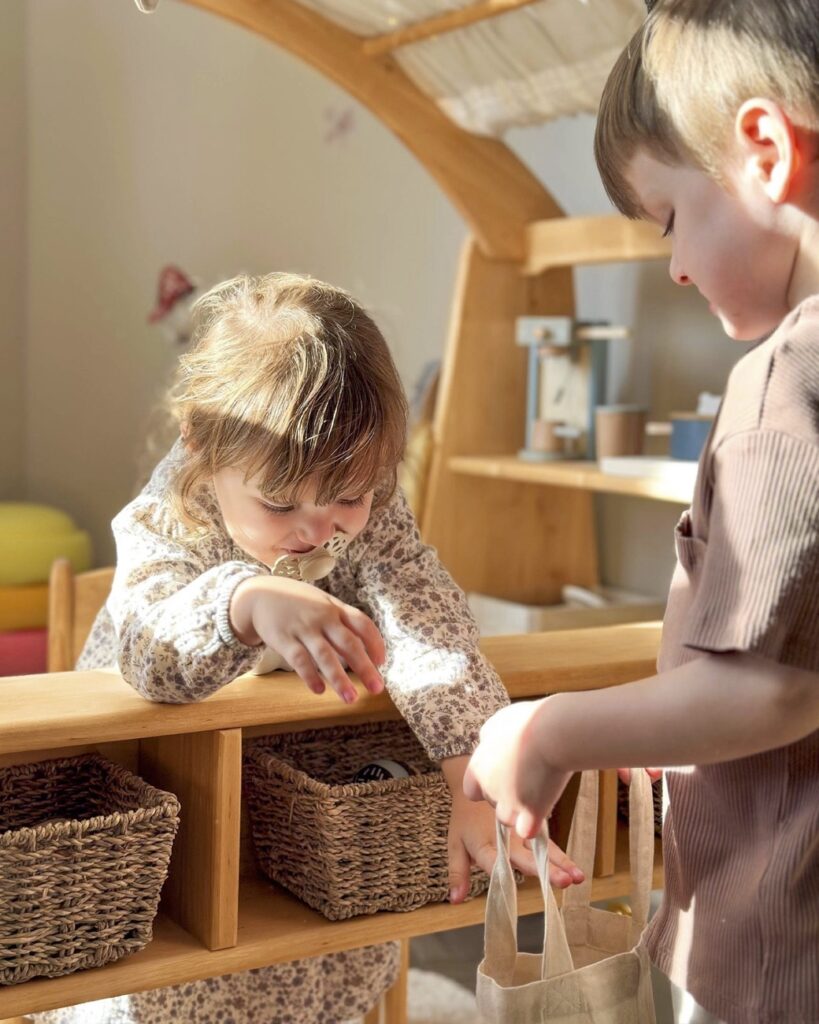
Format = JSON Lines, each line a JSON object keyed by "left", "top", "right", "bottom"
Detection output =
{"left": 19, "top": 0, "right": 739, "bottom": 594}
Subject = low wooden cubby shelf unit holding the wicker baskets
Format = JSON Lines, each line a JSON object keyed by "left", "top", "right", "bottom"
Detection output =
{"left": 0, "top": 624, "right": 661, "bottom": 1019}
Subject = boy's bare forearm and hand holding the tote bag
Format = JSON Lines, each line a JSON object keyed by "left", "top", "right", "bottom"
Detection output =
{"left": 464, "top": 652, "right": 819, "bottom": 839}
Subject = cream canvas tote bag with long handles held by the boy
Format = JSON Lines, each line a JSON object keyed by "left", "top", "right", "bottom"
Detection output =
{"left": 477, "top": 769, "right": 655, "bottom": 1024}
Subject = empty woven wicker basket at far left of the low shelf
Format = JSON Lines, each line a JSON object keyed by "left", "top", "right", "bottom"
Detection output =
{"left": 0, "top": 754, "right": 179, "bottom": 985}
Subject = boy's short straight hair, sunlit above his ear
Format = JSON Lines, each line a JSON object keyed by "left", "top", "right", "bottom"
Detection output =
{"left": 595, "top": 0, "right": 819, "bottom": 217}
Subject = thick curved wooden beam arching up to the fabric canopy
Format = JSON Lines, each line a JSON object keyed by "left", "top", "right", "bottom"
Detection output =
{"left": 178, "top": 0, "right": 563, "bottom": 260}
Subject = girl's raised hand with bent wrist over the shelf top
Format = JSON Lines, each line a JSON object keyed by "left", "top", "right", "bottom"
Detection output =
{"left": 230, "top": 575, "right": 385, "bottom": 703}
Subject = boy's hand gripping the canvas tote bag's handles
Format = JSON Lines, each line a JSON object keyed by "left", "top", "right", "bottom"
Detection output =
{"left": 464, "top": 697, "right": 571, "bottom": 839}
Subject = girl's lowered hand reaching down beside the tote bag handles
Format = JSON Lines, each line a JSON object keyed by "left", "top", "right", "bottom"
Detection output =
{"left": 441, "top": 756, "right": 584, "bottom": 903}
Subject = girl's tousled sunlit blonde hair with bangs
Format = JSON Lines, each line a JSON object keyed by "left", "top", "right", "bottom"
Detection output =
{"left": 169, "top": 273, "right": 406, "bottom": 522}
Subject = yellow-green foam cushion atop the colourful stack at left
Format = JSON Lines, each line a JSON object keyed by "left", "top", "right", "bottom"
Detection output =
{"left": 0, "top": 502, "right": 91, "bottom": 587}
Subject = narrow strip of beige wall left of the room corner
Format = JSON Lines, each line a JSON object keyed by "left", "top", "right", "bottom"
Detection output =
{"left": 0, "top": 0, "right": 26, "bottom": 501}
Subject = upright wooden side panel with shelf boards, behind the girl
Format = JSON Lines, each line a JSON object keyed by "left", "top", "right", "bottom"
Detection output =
{"left": 421, "top": 215, "right": 675, "bottom": 606}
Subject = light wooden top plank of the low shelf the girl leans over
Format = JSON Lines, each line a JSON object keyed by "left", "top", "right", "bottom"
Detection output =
{"left": 0, "top": 623, "right": 659, "bottom": 755}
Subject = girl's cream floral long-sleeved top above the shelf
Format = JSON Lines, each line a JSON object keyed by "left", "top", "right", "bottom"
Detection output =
{"left": 78, "top": 442, "right": 509, "bottom": 761}
